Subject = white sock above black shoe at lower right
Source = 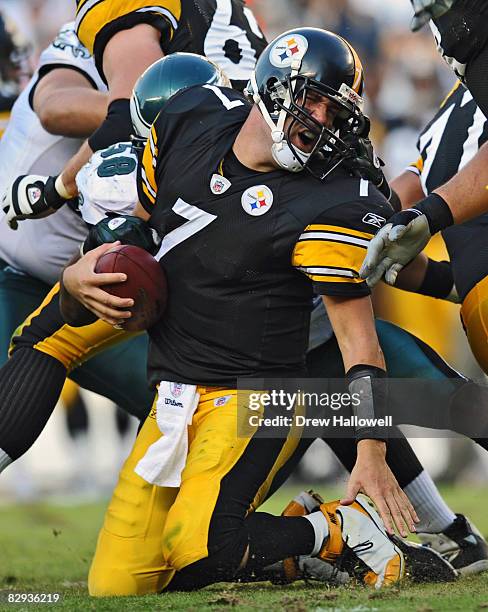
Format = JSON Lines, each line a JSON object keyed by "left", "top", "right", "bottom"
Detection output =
{"left": 404, "top": 470, "right": 456, "bottom": 533}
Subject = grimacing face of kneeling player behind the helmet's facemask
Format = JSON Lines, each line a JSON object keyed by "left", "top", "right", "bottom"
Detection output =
{"left": 285, "top": 91, "right": 339, "bottom": 153}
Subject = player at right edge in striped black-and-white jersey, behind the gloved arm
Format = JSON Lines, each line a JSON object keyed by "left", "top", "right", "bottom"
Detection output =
{"left": 376, "top": 82, "right": 488, "bottom": 380}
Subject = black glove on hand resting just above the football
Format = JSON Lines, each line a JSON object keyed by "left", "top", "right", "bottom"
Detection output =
{"left": 81, "top": 213, "right": 161, "bottom": 255}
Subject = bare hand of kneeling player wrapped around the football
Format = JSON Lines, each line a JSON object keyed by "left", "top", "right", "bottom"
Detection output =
{"left": 63, "top": 242, "right": 134, "bottom": 325}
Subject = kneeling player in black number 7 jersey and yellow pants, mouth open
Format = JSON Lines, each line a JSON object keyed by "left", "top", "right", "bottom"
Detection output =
{"left": 63, "top": 28, "right": 416, "bottom": 595}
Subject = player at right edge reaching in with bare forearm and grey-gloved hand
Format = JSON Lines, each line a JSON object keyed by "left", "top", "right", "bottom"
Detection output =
{"left": 360, "top": 0, "right": 488, "bottom": 285}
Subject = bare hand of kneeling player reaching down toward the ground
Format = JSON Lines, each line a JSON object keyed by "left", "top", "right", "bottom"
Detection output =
{"left": 340, "top": 440, "right": 419, "bottom": 537}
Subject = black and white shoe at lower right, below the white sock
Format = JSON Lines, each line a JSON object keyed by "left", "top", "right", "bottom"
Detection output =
{"left": 419, "top": 514, "right": 488, "bottom": 576}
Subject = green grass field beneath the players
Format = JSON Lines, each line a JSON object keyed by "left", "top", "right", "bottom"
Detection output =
{"left": 0, "top": 487, "right": 488, "bottom": 612}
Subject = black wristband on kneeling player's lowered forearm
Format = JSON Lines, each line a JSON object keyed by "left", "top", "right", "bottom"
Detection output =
{"left": 346, "top": 364, "right": 388, "bottom": 442}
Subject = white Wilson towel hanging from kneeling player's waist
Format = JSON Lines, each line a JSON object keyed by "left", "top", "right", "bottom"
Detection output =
{"left": 135, "top": 381, "right": 200, "bottom": 487}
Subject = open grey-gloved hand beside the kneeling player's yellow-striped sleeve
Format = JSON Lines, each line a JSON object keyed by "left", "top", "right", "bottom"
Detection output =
{"left": 359, "top": 208, "right": 432, "bottom": 287}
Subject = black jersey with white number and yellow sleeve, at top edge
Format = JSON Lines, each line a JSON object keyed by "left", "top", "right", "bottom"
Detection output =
{"left": 76, "top": 0, "right": 267, "bottom": 90}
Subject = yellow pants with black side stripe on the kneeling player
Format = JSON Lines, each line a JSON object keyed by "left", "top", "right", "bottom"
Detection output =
{"left": 88, "top": 387, "right": 299, "bottom": 596}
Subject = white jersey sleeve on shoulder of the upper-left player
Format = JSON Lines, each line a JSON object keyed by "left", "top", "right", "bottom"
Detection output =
{"left": 38, "top": 21, "right": 107, "bottom": 91}
